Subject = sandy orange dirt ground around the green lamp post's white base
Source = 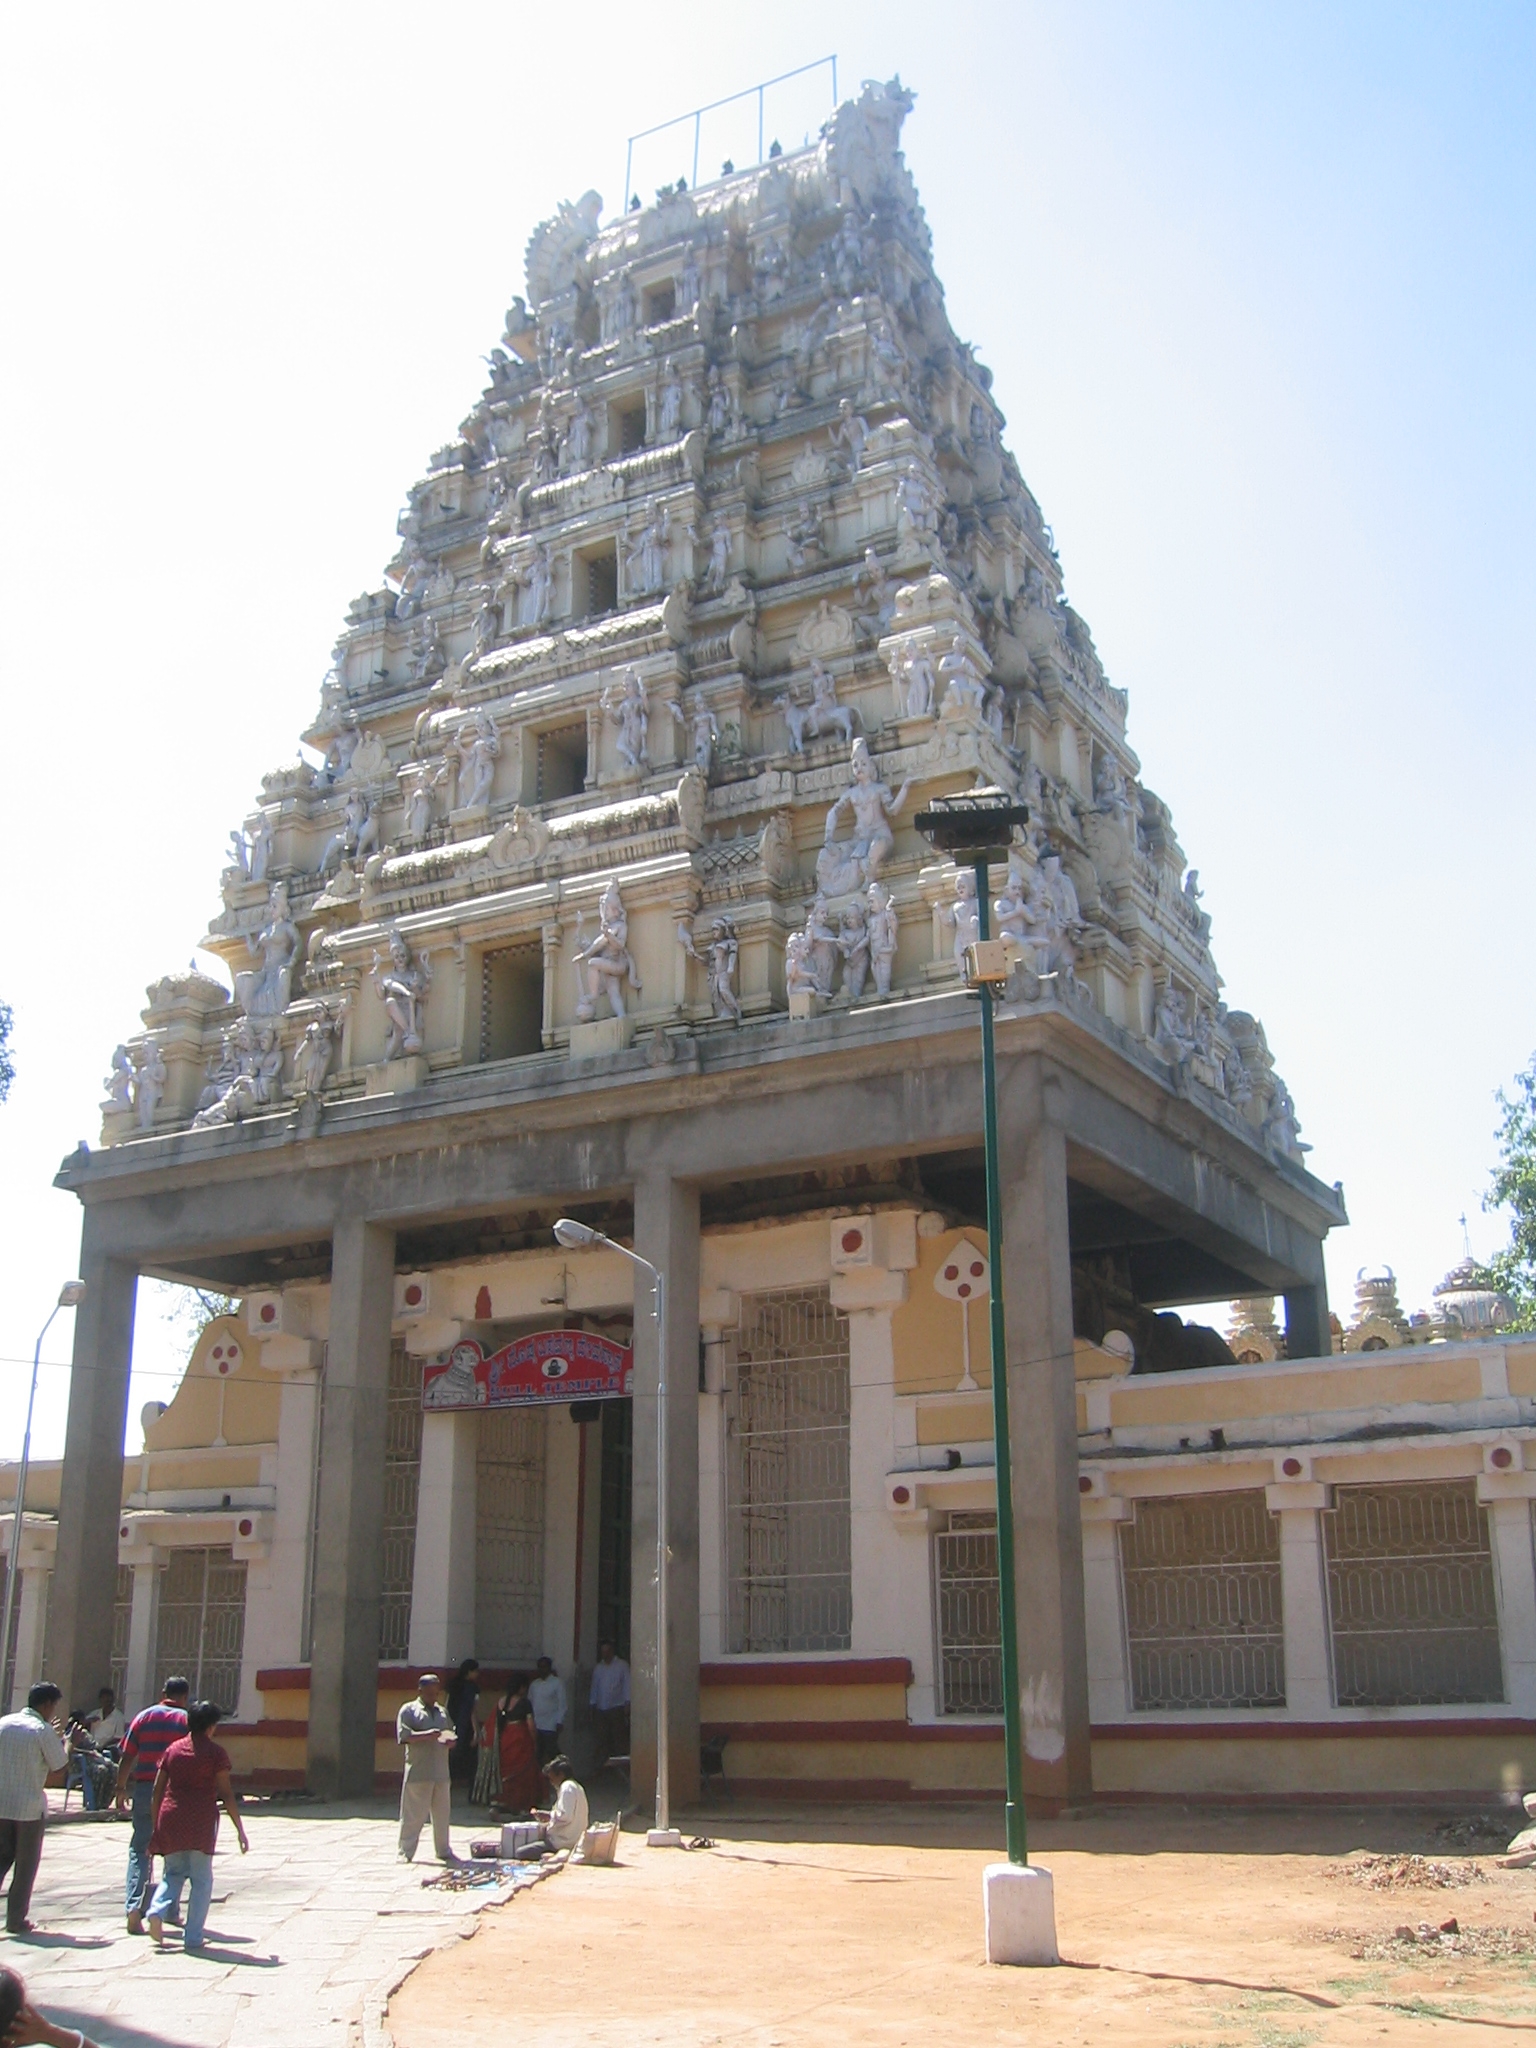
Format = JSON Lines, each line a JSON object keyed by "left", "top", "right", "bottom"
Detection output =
{"left": 389, "top": 1808, "right": 1536, "bottom": 2048}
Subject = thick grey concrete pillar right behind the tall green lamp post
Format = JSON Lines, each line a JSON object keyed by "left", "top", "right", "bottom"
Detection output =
{"left": 997, "top": 1057, "right": 1094, "bottom": 1800}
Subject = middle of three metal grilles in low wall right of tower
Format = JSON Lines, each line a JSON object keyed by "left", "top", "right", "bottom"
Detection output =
{"left": 1120, "top": 1489, "right": 1286, "bottom": 1710}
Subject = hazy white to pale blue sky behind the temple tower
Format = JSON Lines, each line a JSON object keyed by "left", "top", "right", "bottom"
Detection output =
{"left": 0, "top": 0, "right": 1536, "bottom": 1454}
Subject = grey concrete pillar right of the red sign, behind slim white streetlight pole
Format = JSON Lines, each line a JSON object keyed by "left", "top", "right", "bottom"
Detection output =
{"left": 631, "top": 1171, "right": 698, "bottom": 1812}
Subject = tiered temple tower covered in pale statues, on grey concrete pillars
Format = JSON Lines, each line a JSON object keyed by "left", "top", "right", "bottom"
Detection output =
{"left": 51, "top": 82, "right": 1343, "bottom": 1796}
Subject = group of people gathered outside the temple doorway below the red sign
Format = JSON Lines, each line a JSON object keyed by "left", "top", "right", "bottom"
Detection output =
{"left": 395, "top": 1642, "right": 629, "bottom": 1864}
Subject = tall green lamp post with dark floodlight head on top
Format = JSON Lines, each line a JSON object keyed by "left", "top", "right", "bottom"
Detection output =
{"left": 913, "top": 788, "right": 1030, "bottom": 1864}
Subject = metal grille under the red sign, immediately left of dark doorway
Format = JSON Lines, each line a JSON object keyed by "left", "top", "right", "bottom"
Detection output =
{"left": 475, "top": 1409, "right": 547, "bottom": 1663}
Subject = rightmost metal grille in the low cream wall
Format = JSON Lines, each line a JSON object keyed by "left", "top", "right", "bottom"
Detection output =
{"left": 1323, "top": 1479, "right": 1503, "bottom": 1706}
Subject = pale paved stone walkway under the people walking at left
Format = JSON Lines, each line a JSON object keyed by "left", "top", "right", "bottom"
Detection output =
{"left": 0, "top": 1792, "right": 536, "bottom": 2048}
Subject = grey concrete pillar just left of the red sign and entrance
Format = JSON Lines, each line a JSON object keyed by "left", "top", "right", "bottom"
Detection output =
{"left": 307, "top": 1217, "right": 395, "bottom": 1798}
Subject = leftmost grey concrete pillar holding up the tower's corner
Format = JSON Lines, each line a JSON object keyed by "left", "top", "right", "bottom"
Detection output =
{"left": 49, "top": 1245, "right": 139, "bottom": 1702}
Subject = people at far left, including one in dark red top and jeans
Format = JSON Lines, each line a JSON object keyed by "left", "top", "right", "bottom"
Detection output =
{"left": 0, "top": 1677, "right": 250, "bottom": 1966}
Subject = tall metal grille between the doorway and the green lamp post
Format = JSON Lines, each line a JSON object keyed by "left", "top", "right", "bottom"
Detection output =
{"left": 725, "top": 1288, "right": 854, "bottom": 1651}
